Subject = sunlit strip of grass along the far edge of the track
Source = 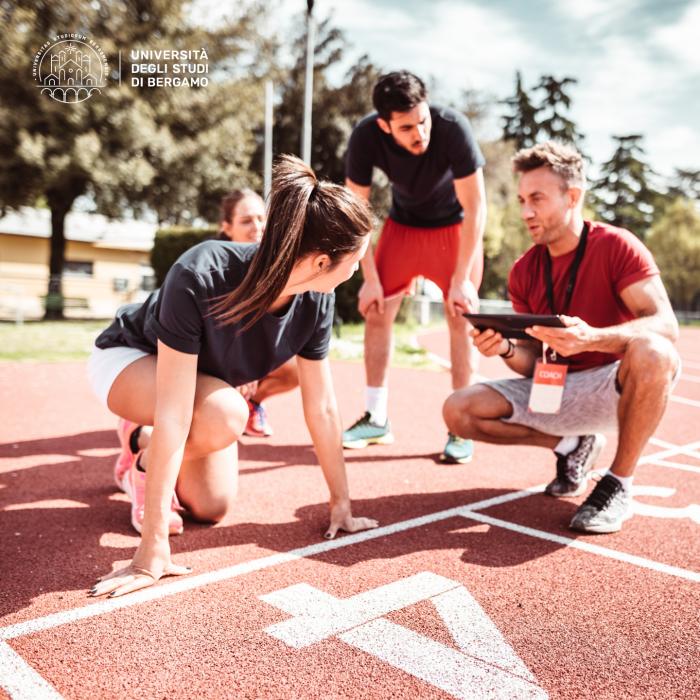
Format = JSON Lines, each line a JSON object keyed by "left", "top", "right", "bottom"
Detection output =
{"left": 0, "top": 320, "right": 446, "bottom": 369}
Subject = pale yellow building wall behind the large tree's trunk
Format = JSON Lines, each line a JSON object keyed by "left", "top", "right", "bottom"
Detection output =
{"left": 0, "top": 233, "right": 149, "bottom": 318}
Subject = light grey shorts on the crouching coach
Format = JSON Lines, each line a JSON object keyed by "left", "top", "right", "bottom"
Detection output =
{"left": 482, "top": 360, "right": 680, "bottom": 436}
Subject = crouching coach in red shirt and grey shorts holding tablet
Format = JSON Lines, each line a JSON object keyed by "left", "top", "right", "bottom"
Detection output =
{"left": 443, "top": 142, "right": 680, "bottom": 532}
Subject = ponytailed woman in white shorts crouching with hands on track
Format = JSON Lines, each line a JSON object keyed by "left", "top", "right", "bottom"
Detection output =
{"left": 88, "top": 156, "right": 377, "bottom": 596}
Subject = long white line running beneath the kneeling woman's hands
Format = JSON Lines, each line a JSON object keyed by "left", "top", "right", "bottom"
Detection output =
{"left": 0, "top": 442, "right": 700, "bottom": 640}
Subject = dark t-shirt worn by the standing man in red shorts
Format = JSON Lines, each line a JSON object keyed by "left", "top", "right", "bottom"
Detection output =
{"left": 346, "top": 105, "right": 485, "bottom": 228}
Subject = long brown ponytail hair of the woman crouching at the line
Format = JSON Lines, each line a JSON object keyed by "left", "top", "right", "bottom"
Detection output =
{"left": 211, "top": 155, "right": 373, "bottom": 330}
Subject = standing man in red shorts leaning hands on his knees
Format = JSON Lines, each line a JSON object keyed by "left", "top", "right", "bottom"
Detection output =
{"left": 343, "top": 71, "right": 486, "bottom": 464}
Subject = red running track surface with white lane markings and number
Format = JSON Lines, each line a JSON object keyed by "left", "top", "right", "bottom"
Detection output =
{"left": 0, "top": 329, "right": 700, "bottom": 698}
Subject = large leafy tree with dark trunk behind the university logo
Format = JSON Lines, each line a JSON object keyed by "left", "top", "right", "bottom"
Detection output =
{"left": 0, "top": 0, "right": 269, "bottom": 318}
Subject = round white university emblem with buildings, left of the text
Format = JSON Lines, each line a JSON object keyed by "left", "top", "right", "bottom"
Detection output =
{"left": 33, "top": 34, "right": 109, "bottom": 103}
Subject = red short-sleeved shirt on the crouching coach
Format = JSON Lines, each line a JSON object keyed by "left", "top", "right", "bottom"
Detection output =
{"left": 508, "top": 221, "right": 659, "bottom": 372}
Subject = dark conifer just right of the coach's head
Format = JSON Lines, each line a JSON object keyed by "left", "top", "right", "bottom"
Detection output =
{"left": 592, "top": 134, "right": 661, "bottom": 240}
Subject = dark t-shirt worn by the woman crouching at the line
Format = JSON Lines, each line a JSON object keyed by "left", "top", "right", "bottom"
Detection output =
{"left": 95, "top": 241, "right": 335, "bottom": 386}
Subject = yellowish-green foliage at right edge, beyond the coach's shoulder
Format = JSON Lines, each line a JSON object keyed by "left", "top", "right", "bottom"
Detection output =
{"left": 647, "top": 198, "right": 700, "bottom": 309}
